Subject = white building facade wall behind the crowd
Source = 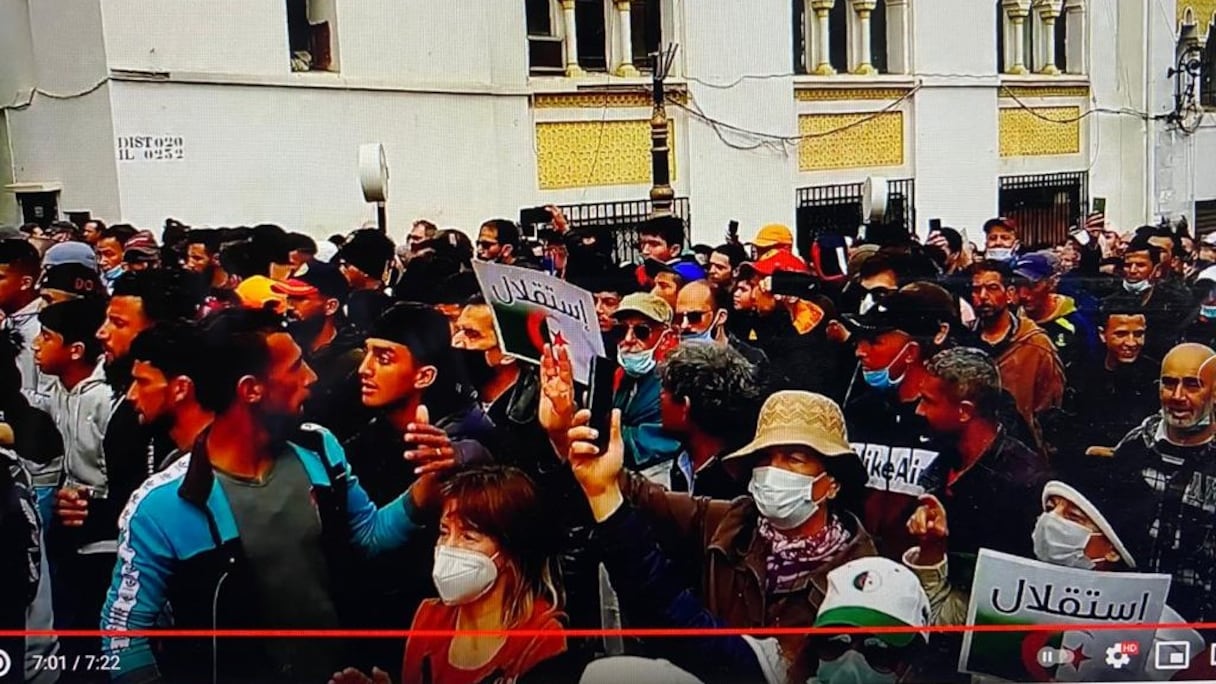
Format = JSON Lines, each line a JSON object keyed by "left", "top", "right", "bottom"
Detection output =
{"left": 0, "top": 0, "right": 1216, "bottom": 242}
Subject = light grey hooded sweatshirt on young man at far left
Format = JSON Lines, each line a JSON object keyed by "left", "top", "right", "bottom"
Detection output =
{"left": 49, "top": 363, "right": 118, "bottom": 554}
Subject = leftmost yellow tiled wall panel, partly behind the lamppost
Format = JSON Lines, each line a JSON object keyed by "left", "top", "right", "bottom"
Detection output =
{"left": 536, "top": 120, "right": 676, "bottom": 190}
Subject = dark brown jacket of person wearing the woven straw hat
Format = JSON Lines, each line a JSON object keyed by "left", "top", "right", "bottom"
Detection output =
{"left": 623, "top": 473, "right": 878, "bottom": 660}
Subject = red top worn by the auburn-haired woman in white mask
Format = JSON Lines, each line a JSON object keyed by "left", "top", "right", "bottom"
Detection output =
{"left": 401, "top": 599, "right": 565, "bottom": 684}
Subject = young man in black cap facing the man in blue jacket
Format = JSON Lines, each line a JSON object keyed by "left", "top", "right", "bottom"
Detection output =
{"left": 343, "top": 303, "right": 494, "bottom": 669}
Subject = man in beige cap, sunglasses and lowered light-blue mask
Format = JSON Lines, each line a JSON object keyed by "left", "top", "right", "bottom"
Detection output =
{"left": 613, "top": 292, "right": 680, "bottom": 481}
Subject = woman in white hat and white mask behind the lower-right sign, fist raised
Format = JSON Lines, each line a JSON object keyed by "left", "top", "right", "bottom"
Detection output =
{"left": 903, "top": 473, "right": 1203, "bottom": 679}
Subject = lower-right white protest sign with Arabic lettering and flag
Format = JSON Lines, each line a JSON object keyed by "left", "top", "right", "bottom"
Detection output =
{"left": 958, "top": 549, "right": 1170, "bottom": 682}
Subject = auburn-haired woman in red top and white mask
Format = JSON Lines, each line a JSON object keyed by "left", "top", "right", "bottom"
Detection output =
{"left": 331, "top": 466, "right": 567, "bottom": 684}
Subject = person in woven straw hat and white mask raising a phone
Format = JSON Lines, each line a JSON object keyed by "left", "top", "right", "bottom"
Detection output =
{"left": 554, "top": 392, "right": 877, "bottom": 682}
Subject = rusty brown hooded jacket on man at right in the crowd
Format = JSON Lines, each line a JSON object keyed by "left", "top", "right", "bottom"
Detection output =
{"left": 991, "top": 316, "right": 1064, "bottom": 445}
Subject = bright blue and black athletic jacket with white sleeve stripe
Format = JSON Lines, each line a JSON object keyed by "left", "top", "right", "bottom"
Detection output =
{"left": 101, "top": 425, "right": 421, "bottom": 683}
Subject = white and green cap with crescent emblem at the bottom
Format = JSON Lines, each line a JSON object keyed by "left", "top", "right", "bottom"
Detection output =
{"left": 815, "top": 556, "right": 931, "bottom": 646}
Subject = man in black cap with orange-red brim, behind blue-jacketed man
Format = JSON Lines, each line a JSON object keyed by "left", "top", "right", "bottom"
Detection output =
{"left": 271, "top": 262, "right": 370, "bottom": 439}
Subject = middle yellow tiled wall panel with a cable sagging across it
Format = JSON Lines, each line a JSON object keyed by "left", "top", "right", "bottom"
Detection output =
{"left": 798, "top": 112, "right": 903, "bottom": 172}
